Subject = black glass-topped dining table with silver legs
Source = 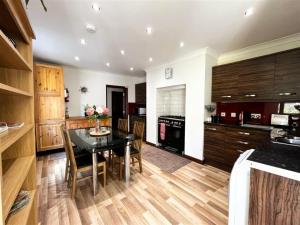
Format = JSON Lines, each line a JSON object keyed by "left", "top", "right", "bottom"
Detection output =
{"left": 69, "top": 127, "right": 137, "bottom": 196}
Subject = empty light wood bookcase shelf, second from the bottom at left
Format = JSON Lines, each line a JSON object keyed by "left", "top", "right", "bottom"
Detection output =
{"left": 2, "top": 156, "right": 35, "bottom": 218}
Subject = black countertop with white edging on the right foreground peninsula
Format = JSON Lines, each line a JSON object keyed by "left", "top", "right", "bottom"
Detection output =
{"left": 248, "top": 142, "right": 300, "bottom": 173}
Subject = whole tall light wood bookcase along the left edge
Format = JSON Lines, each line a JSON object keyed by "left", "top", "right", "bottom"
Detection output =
{"left": 0, "top": 0, "right": 37, "bottom": 225}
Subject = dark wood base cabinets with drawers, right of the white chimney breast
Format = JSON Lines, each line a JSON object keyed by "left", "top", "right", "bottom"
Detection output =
{"left": 204, "top": 124, "right": 270, "bottom": 171}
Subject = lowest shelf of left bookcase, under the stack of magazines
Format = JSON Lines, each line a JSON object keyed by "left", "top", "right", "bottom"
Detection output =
{"left": 6, "top": 190, "right": 36, "bottom": 225}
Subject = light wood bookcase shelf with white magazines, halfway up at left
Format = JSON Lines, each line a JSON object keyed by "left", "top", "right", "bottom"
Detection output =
{"left": 0, "top": 124, "right": 33, "bottom": 153}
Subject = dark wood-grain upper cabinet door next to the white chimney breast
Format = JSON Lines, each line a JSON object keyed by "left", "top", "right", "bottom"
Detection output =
{"left": 212, "top": 64, "right": 238, "bottom": 102}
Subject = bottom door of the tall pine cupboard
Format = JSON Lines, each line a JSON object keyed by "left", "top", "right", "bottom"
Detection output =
{"left": 37, "top": 123, "right": 63, "bottom": 151}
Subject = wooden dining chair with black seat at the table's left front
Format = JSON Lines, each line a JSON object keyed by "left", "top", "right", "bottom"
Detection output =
{"left": 61, "top": 125, "right": 106, "bottom": 198}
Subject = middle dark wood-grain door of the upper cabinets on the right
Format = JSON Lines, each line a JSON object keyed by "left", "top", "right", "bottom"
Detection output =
{"left": 238, "top": 55, "right": 275, "bottom": 102}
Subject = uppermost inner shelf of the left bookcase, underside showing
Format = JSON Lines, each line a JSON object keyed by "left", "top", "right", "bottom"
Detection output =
{"left": 0, "top": 30, "right": 32, "bottom": 71}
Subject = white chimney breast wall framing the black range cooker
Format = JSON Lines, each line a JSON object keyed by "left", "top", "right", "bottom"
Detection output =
{"left": 146, "top": 49, "right": 216, "bottom": 160}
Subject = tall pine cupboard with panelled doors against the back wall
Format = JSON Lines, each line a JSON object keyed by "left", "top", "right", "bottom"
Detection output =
{"left": 34, "top": 63, "right": 65, "bottom": 152}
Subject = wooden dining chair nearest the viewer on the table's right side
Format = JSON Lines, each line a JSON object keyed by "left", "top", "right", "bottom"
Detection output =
{"left": 112, "top": 121, "right": 145, "bottom": 180}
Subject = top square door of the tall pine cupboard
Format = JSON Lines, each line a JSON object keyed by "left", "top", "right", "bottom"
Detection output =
{"left": 36, "top": 66, "right": 63, "bottom": 95}
